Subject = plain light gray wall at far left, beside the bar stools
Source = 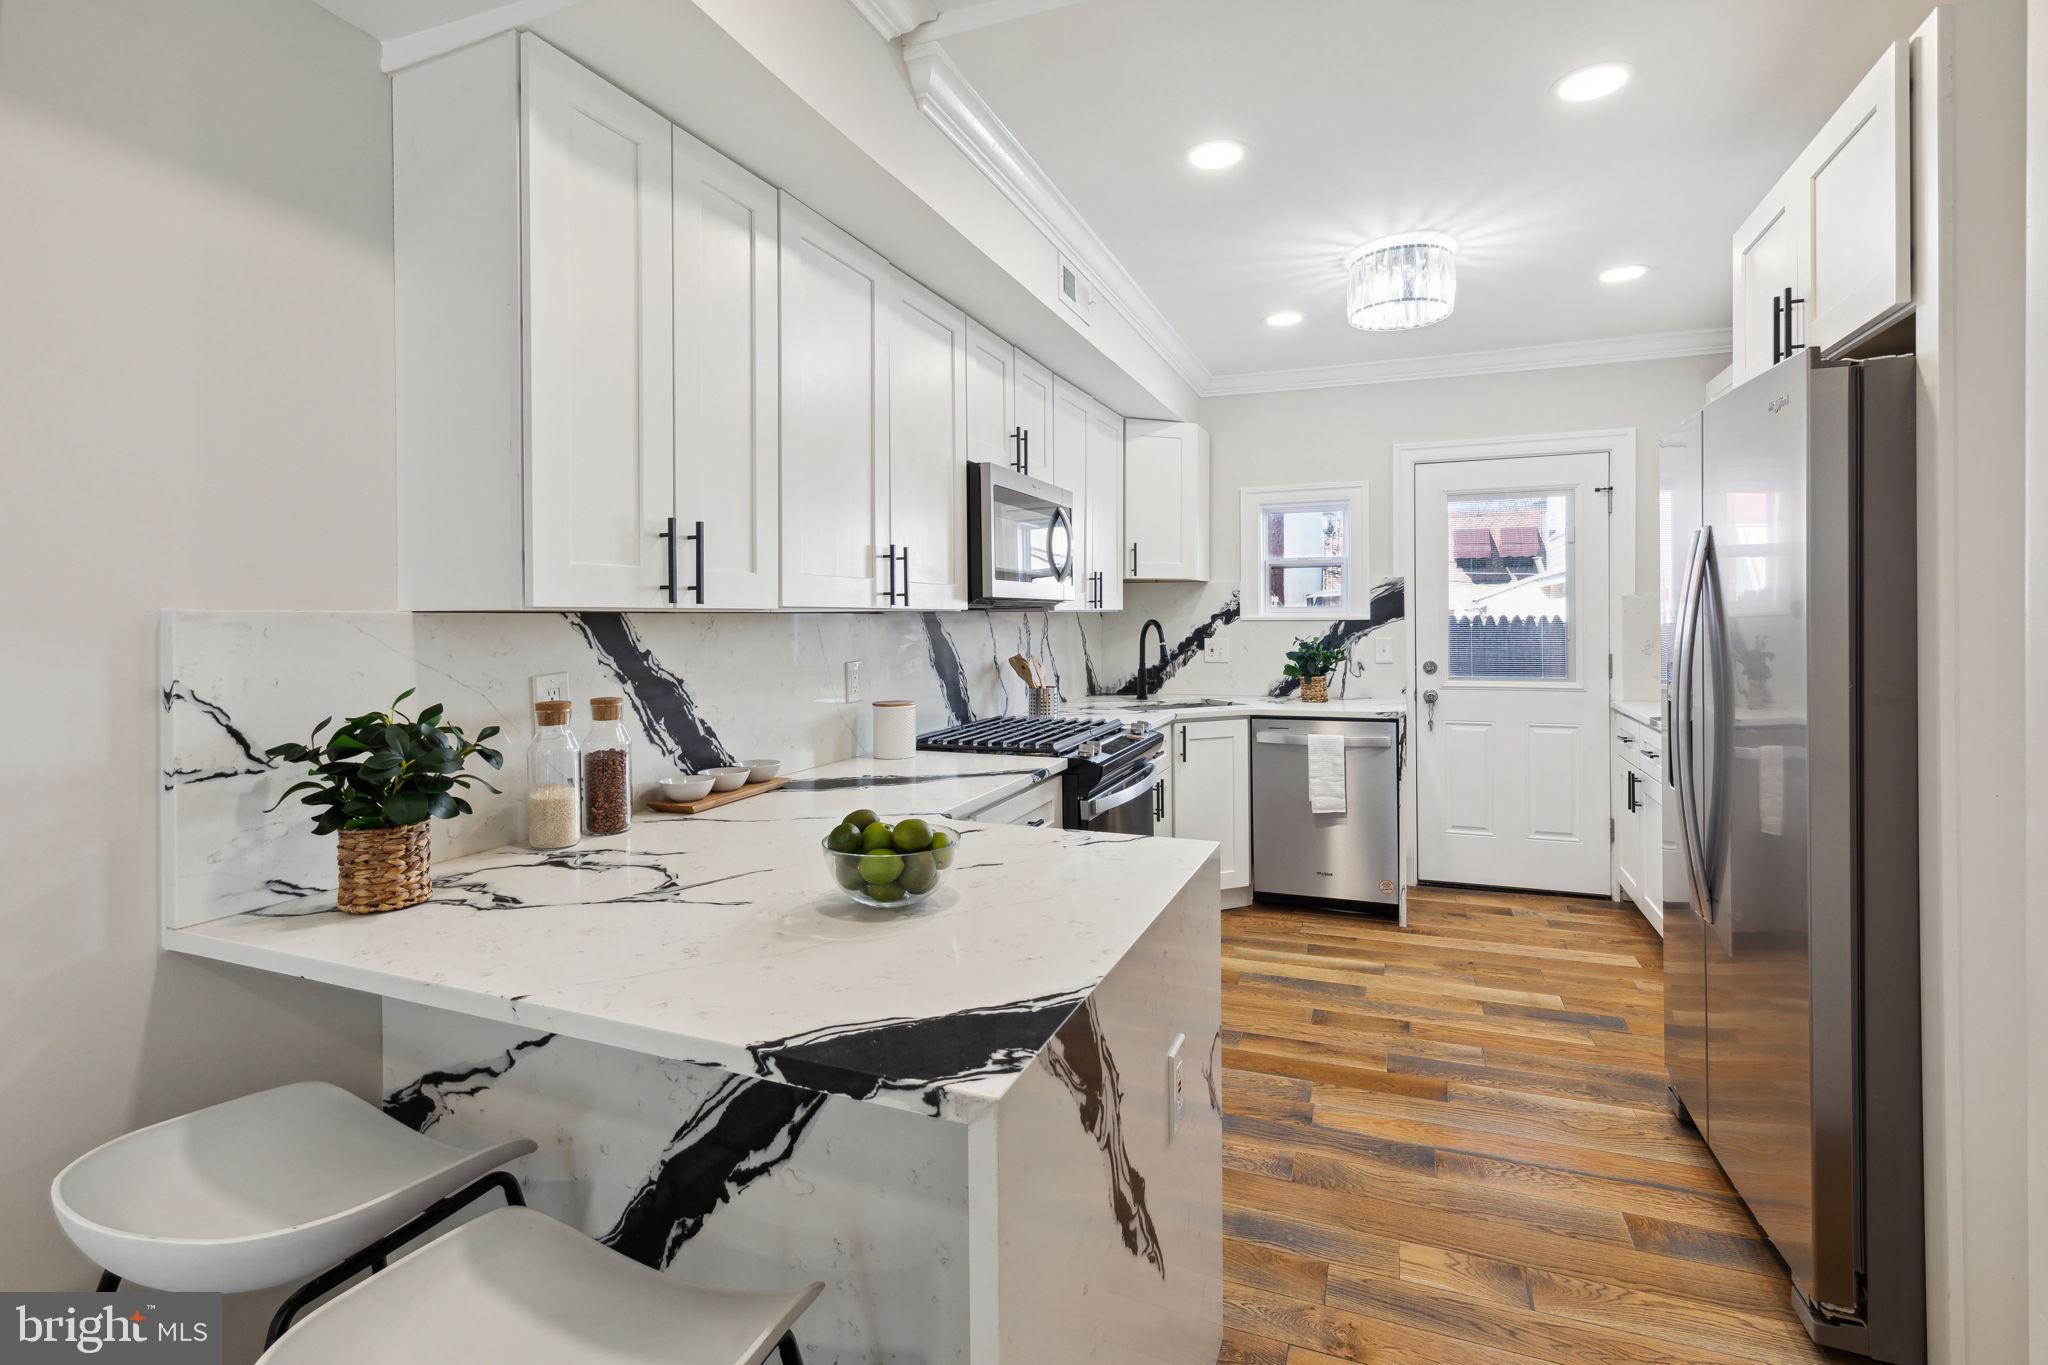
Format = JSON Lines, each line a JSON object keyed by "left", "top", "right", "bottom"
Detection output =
{"left": 0, "top": 0, "right": 395, "bottom": 1355}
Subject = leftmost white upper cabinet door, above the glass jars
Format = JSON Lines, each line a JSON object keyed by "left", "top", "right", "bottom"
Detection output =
{"left": 520, "top": 35, "right": 676, "bottom": 608}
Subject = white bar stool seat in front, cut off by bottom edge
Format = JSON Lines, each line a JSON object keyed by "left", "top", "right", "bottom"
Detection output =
{"left": 256, "top": 1207, "right": 825, "bottom": 1365}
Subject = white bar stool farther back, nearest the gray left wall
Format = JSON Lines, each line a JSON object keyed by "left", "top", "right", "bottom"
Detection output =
{"left": 49, "top": 1081, "right": 535, "bottom": 1340}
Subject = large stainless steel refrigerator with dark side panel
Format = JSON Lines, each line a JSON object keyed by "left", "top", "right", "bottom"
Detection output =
{"left": 1659, "top": 352, "right": 1925, "bottom": 1365}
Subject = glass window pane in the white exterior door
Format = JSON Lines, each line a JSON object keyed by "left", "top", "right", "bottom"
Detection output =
{"left": 1446, "top": 489, "right": 1571, "bottom": 679}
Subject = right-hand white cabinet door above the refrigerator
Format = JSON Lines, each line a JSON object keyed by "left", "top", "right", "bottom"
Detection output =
{"left": 1800, "top": 43, "right": 1913, "bottom": 350}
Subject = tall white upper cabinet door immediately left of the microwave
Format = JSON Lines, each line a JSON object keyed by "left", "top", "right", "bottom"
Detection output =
{"left": 883, "top": 270, "right": 967, "bottom": 612}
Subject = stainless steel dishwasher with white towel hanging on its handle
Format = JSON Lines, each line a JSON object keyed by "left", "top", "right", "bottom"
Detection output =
{"left": 1251, "top": 718, "right": 1401, "bottom": 913}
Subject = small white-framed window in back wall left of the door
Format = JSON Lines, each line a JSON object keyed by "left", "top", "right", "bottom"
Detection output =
{"left": 1241, "top": 483, "right": 1366, "bottom": 620}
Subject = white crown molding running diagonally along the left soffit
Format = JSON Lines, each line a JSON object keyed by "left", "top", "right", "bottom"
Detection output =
{"left": 901, "top": 41, "right": 1210, "bottom": 393}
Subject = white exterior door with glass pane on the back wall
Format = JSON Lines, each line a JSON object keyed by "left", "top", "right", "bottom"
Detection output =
{"left": 1413, "top": 452, "right": 1610, "bottom": 896}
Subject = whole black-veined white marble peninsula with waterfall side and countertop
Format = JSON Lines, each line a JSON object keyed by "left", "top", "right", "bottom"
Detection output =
{"left": 164, "top": 753, "right": 1223, "bottom": 1365}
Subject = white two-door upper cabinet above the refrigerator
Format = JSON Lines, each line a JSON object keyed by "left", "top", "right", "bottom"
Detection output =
{"left": 1733, "top": 43, "right": 1913, "bottom": 383}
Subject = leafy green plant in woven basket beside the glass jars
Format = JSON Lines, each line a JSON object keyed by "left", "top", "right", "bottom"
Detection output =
{"left": 264, "top": 688, "right": 504, "bottom": 915}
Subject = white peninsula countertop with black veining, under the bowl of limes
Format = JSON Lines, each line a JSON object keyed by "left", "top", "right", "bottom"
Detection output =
{"left": 164, "top": 753, "right": 1214, "bottom": 1121}
